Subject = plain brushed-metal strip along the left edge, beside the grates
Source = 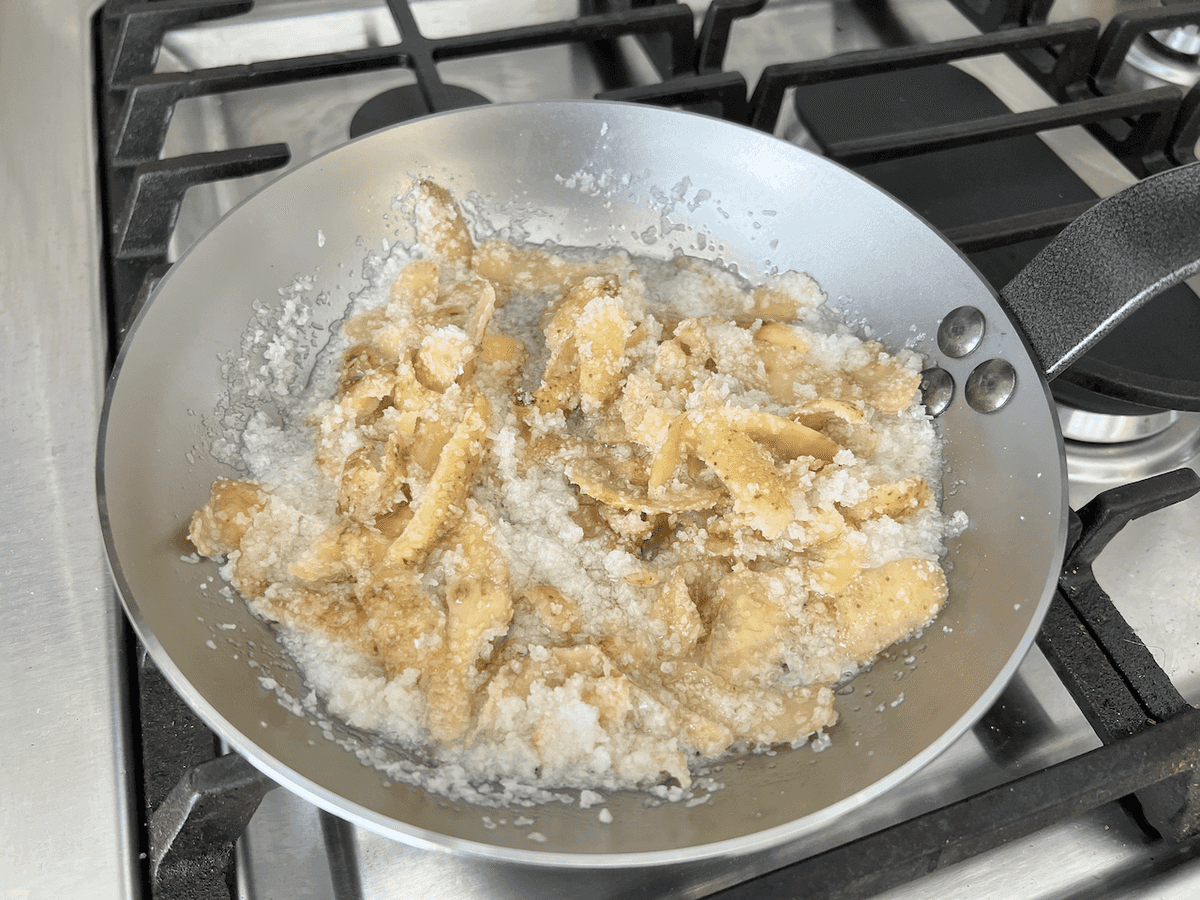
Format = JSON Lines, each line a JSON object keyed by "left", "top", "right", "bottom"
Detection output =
{"left": 0, "top": 0, "right": 137, "bottom": 900}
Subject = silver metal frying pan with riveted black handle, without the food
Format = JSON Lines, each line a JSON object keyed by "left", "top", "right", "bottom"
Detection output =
{"left": 98, "top": 102, "right": 1200, "bottom": 866}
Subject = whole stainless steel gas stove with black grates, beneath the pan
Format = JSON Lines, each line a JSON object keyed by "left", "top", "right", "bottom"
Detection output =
{"left": 0, "top": 0, "right": 1200, "bottom": 899}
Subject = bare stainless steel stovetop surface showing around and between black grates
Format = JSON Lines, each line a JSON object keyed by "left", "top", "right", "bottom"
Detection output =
{"left": 0, "top": 0, "right": 1200, "bottom": 900}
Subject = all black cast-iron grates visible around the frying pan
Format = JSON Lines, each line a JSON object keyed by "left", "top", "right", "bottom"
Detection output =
{"left": 96, "top": 0, "right": 1200, "bottom": 900}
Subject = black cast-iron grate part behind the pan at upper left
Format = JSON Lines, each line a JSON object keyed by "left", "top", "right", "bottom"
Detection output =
{"left": 96, "top": 0, "right": 764, "bottom": 344}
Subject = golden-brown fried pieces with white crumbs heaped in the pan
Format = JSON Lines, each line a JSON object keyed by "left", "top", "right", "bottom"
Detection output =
{"left": 190, "top": 181, "right": 946, "bottom": 786}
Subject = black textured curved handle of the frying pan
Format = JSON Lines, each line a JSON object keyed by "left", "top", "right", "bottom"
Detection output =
{"left": 1001, "top": 163, "right": 1200, "bottom": 378}
